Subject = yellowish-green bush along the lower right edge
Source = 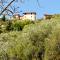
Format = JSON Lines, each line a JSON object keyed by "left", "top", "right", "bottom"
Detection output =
{"left": 44, "top": 24, "right": 60, "bottom": 60}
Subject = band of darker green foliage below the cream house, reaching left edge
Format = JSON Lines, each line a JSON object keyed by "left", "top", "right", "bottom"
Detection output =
{"left": 0, "top": 20, "right": 34, "bottom": 33}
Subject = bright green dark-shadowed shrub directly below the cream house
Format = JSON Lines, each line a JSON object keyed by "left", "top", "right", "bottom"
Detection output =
{"left": 13, "top": 20, "right": 33, "bottom": 31}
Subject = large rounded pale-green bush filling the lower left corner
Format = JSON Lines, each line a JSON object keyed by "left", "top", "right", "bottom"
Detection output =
{"left": 0, "top": 32, "right": 33, "bottom": 60}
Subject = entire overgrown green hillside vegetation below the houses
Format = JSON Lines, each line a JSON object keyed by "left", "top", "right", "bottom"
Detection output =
{"left": 0, "top": 14, "right": 60, "bottom": 60}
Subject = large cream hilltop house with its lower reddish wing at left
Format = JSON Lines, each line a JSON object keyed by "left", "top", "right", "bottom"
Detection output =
{"left": 13, "top": 12, "right": 36, "bottom": 21}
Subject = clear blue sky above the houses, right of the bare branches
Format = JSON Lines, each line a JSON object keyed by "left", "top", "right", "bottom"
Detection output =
{"left": 18, "top": 0, "right": 60, "bottom": 18}
